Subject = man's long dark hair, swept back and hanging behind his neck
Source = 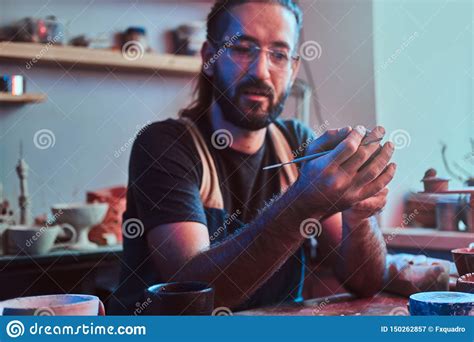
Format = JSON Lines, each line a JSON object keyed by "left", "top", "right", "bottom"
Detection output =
{"left": 179, "top": 0, "right": 303, "bottom": 121}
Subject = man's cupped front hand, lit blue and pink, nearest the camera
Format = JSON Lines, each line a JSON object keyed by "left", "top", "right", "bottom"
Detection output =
{"left": 295, "top": 126, "right": 396, "bottom": 216}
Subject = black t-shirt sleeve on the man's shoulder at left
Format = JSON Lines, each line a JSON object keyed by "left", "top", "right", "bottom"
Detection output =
{"left": 127, "top": 120, "right": 207, "bottom": 231}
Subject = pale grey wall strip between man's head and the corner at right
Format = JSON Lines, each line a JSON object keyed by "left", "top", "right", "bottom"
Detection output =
{"left": 294, "top": 0, "right": 375, "bottom": 128}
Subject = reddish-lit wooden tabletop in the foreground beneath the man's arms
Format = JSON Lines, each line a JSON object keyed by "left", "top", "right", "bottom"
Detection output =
{"left": 236, "top": 293, "right": 408, "bottom": 316}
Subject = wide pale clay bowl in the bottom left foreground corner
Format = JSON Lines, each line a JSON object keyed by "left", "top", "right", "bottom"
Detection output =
{"left": 0, "top": 294, "right": 105, "bottom": 316}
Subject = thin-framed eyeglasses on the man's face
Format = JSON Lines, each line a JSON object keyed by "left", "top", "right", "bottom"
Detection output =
{"left": 216, "top": 43, "right": 300, "bottom": 70}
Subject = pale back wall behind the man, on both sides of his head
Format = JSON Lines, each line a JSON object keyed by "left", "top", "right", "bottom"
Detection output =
{"left": 0, "top": 0, "right": 375, "bottom": 220}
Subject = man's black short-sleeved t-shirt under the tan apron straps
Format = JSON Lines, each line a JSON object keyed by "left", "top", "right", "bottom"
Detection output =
{"left": 112, "top": 116, "right": 313, "bottom": 314}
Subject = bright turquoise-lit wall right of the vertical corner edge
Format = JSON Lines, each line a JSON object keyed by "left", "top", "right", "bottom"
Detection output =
{"left": 374, "top": 0, "right": 474, "bottom": 226}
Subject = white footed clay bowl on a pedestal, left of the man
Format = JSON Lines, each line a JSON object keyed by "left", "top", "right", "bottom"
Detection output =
{"left": 51, "top": 203, "right": 109, "bottom": 250}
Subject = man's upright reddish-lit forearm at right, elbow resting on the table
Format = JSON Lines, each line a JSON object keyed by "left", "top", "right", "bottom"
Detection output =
{"left": 335, "top": 216, "right": 387, "bottom": 297}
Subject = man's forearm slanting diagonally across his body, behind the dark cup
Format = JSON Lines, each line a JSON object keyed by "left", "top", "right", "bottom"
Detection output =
{"left": 173, "top": 187, "right": 324, "bottom": 308}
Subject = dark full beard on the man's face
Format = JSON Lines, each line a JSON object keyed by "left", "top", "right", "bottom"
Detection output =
{"left": 214, "top": 75, "right": 290, "bottom": 131}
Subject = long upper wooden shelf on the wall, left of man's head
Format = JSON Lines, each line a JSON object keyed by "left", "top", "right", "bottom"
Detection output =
{"left": 0, "top": 42, "right": 201, "bottom": 75}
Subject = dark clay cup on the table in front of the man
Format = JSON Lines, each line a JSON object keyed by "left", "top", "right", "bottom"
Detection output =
{"left": 145, "top": 281, "right": 214, "bottom": 316}
